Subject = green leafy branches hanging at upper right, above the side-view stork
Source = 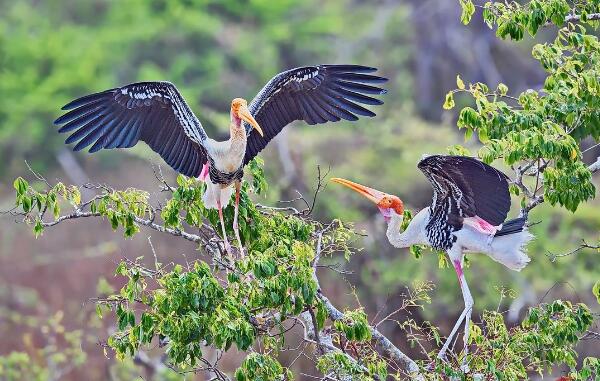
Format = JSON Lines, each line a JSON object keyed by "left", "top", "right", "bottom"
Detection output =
{"left": 454, "top": 0, "right": 600, "bottom": 212}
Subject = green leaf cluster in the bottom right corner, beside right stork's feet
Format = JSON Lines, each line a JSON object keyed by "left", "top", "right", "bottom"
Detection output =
{"left": 428, "top": 300, "right": 597, "bottom": 380}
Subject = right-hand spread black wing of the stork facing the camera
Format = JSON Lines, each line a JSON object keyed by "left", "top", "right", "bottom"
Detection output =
{"left": 244, "top": 65, "right": 387, "bottom": 164}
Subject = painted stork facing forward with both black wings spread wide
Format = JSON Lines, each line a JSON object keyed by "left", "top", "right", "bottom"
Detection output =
{"left": 54, "top": 65, "right": 387, "bottom": 256}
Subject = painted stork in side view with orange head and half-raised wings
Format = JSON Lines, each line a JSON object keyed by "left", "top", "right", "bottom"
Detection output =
{"left": 331, "top": 155, "right": 533, "bottom": 359}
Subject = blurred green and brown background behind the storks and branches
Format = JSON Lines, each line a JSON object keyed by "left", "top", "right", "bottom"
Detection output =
{"left": 0, "top": 0, "right": 600, "bottom": 380}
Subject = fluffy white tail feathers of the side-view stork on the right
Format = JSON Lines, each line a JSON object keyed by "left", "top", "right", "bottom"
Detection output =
{"left": 489, "top": 226, "right": 533, "bottom": 271}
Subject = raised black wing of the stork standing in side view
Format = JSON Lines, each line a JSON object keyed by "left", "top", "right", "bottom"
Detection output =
{"left": 418, "top": 155, "right": 510, "bottom": 226}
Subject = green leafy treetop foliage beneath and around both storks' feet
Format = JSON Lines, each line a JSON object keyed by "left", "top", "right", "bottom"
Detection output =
{"left": 14, "top": 161, "right": 597, "bottom": 380}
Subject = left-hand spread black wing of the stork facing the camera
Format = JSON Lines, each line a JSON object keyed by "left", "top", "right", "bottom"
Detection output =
{"left": 54, "top": 82, "right": 207, "bottom": 176}
